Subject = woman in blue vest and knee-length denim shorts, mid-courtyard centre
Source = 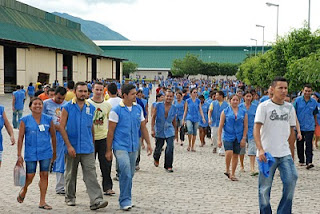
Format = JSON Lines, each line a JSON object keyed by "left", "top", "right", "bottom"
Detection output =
{"left": 182, "top": 88, "right": 206, "bottom": 152}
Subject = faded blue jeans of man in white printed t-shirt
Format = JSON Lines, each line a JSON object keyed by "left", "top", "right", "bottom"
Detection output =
{"left": 259, "top": 155, "right": 298, "bottom": 214}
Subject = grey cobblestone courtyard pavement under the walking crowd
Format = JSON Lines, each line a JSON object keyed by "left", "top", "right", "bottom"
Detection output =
{"left": 0, "top": 91, "right": 320, "bottom": 214}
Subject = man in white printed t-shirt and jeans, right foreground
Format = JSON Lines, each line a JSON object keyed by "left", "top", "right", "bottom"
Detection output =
{"left": 253, "top": 77, "right": 298, "bottom": 214}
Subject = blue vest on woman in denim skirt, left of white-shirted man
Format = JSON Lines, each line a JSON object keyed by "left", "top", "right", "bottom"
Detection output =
{"left": 222, "top": 106, "right": 246, "bottom": 143}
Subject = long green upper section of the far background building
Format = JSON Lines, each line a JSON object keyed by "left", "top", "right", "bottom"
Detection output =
{"left": 100, "top": 45, "right": 270, "bottom": 68}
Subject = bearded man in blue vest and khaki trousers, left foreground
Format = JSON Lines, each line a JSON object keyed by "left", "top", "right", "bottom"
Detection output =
{"left": 60, "top": 82, "right": 108, "bottom": 210}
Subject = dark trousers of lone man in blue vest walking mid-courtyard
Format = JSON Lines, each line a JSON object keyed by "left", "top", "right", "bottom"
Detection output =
{"left": 153, "top": 136, "right": 174, "bottom": 169}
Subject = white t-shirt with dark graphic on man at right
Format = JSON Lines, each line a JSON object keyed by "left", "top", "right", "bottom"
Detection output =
{"left": 254, "top": 100, "right": 296, "bottom": 157}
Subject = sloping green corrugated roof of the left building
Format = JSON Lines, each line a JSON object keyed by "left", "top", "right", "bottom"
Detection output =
{"left": 0, "top": 0, "right": 104, "bottom": 56}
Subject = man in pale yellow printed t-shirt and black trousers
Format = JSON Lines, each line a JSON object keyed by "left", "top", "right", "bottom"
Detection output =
{"left": 88, "top": 82, "right": 115, "bottom": 195}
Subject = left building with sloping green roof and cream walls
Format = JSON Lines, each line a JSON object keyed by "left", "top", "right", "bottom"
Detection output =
{"left": 0, "top": 0, "right": 123, "bottom": 93}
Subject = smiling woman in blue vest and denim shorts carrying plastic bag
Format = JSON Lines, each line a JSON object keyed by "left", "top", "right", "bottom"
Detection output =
{"left": 17, "top": 97, "right": 56, "bottom": 210}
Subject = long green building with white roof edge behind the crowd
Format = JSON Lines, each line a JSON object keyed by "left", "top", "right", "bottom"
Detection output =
{"left": 94, "top": 40, "right": 270, "bottom": 79}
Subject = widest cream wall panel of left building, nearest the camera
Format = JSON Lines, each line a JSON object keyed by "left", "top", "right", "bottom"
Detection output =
{"left": 24, "top": 47, "right": 56, "bottom": 86}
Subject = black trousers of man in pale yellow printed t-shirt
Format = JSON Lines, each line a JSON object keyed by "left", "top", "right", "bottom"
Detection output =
{"left": 95, "top": 138, "right": 112, "bottom": 192}
